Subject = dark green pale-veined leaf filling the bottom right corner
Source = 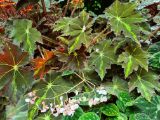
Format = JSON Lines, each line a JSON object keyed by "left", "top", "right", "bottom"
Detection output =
{"left": 135, "top": 95, "right": 160, "bottom": 120}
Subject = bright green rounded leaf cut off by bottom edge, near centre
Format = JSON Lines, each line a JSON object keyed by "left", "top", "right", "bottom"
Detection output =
{"left": 78, "top": 112, "right": 100, "bottom": 120}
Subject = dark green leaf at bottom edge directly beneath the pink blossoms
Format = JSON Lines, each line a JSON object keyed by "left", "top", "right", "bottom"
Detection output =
{"left": 62, "top": 107, "right": 84, "bottom": 120}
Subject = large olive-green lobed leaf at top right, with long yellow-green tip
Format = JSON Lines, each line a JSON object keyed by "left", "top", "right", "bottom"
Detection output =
{"left": 105, "top": 0, "right": 144, "bottom": 43}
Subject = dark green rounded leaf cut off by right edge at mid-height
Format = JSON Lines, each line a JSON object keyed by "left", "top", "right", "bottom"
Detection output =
{"left": 148, "top": 42, "right": 160, "bottom": 70}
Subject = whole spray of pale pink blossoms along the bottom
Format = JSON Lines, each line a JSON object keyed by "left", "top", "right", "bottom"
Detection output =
{"left": 25, "top": 87, "right": 108, "bottom": 117}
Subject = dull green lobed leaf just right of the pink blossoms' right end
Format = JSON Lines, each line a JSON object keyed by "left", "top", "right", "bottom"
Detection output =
{"left": 102, "top": 76, "right": 128, "bottom": 96}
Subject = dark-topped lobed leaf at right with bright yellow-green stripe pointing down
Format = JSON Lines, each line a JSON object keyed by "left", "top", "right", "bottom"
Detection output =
{"left": 118, "top": 45, "right": 148, "bottom": 78}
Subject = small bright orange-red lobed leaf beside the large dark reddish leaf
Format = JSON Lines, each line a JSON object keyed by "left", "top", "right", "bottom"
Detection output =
{"left": 33, "top": 50, "right": 54, "bottom": 78}
